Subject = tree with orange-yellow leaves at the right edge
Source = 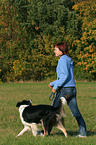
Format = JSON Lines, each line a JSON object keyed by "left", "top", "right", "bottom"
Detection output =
{"left": 73, "top": 1, "right": 96, "bottom": 79}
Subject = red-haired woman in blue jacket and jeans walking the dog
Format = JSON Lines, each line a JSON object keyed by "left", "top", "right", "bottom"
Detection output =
{"left": 48, "top": 42, "right": 87, "bottom": 137}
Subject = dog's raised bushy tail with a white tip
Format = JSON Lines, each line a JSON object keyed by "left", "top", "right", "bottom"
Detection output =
{"left": 57, "top": 97, "right": 66, "bottom": 117}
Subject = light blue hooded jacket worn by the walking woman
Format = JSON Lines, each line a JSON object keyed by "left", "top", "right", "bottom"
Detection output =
{"left": 50, "top": 55, "right": 75, "bottom": 90}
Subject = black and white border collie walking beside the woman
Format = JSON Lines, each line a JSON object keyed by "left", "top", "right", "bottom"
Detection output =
{"left": 16, "top": 97, "right": 67, "bottom": 137}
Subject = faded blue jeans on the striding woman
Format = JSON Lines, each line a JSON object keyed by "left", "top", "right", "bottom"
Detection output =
{"left": 52, "top": 87, "right": 86, "bottom": 136}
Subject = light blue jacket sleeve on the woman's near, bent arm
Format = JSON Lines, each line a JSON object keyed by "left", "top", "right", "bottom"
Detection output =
{"left": 50, "top": 60, "right": 69, "bottom": 90}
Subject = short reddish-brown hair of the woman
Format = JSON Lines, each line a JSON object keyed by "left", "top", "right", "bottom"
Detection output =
{"left": 55, "top": 42, "right": 69, "bottom": 55}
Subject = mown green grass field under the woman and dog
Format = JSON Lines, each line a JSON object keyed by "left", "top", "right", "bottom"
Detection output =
{"left": 0, "top": 82, "right": 96, "bottom": 145}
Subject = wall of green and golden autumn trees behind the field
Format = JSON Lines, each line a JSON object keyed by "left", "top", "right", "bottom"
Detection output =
{"left": 0, "top": 0, "right": 96, "bottom": 82}
